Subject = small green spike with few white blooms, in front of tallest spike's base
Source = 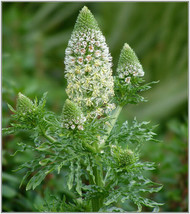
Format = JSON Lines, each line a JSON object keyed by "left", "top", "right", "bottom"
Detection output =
{"left": 61, "top": 99, "right": 86, "bottom": 130}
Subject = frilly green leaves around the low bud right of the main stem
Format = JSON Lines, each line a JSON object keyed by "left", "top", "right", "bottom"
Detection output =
{"left": 96, "top": 119, "right": 162, "bottom": 211}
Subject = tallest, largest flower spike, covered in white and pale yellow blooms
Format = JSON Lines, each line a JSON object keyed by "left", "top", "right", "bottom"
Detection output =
{"left": 65, "top": 7, "right": 114, "bottom": 117}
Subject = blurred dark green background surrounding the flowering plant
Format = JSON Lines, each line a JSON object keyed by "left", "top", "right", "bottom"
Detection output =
{"left": 2, "top": 2, "right": 188, "bottom": 212}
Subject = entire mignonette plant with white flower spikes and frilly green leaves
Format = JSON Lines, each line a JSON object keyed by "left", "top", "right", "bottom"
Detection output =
{"left": 4, "top": 7, "right": 162, "bottom": 212}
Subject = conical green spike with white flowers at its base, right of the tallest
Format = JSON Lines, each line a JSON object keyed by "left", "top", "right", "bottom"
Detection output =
{"left": 117, "top": 43, "right": 144, "bottom": 84}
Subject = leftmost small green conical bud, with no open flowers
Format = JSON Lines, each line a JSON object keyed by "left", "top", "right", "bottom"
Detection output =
{"left": 16, "top": 92, "right": 34, "bottom": 112}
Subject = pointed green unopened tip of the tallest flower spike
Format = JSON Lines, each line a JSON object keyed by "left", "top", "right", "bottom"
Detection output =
{"left": 74, "top": 6, "right": 99, "bottom": 31}
